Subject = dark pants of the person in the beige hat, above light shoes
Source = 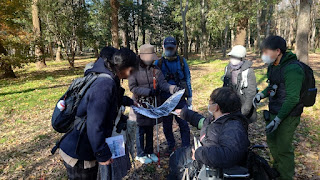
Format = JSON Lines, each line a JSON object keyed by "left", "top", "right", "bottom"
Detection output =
{"left": 136, "top": 126, "right": 153, "bottom": 157}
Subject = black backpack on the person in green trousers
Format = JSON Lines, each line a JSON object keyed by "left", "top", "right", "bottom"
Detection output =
{"left": 296, "top": 61, "right": 317, "bottom": 107}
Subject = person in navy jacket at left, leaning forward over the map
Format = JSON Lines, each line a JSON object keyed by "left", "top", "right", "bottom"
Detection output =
{"left": 59, "top": 47, "right": 137, "bottom": 179}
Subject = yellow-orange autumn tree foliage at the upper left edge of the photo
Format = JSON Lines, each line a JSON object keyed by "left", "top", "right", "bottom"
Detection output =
{"left": 0, "top": 0, "right": 34, "bottom": 78}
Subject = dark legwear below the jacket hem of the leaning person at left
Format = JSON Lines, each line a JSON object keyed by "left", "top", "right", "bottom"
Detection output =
{"left": 63, "top": 160, "right": 98, "bottom": 180}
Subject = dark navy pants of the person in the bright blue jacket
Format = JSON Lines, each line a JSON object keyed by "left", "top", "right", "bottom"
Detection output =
{"left": 162, "top": 100, "right": 190, "bottom": 148}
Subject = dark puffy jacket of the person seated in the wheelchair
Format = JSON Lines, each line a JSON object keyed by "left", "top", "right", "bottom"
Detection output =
{"left": 180, "top": 108, "right": 250, "bottom": 168}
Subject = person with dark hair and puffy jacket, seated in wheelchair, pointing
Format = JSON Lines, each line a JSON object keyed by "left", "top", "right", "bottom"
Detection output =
{"left": 170, "top": 87, "right": 250, "bottom": 179}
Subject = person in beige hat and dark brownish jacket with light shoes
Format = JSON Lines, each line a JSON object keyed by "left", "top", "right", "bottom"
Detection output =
{"left": 129, "top": 44, "right": 180, "bottom": 164}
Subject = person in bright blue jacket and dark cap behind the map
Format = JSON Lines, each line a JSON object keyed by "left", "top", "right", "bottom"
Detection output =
{"left": 155, "top": 36, "right": 192, "bottom": 156}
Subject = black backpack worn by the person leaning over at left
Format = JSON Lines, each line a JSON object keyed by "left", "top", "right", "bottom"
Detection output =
{"left": 51, "top": 73, "right": 112, "bottom": 154}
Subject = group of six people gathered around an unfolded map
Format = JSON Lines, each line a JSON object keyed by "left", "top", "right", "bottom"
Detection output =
{"left": 59, "top": 36, "right": 304, "bottom": 180}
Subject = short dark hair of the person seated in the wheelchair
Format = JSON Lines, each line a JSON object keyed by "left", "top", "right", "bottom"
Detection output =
{"left": 210, "top": 87, "right": 241, "bottom": 113}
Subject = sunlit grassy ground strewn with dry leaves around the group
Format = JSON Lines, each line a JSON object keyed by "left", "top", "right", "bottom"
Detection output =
{"left": 0, "top": 54, "right": 320, "bottom": 179}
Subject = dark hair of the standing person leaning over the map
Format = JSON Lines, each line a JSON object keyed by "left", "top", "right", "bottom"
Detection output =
{"left": 110, "top": 48, "right": 138, "bottom": 71}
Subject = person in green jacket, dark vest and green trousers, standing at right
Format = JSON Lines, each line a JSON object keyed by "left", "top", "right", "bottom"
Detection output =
{"left": 253, "top": 36, "right": 304, "bottom": 180}
